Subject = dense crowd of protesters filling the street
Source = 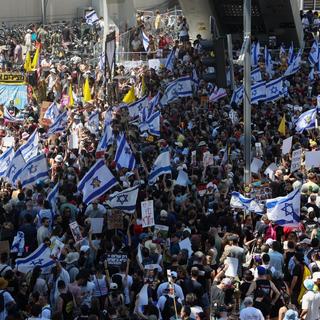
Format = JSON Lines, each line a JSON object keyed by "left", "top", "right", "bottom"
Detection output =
{"left": 0, "top": 6, "right": 320, "bottom": 320}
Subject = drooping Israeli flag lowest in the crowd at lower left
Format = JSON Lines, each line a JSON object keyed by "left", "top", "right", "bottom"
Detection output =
{"left": 16, "top": 243, "right": 56, "bottom": 273}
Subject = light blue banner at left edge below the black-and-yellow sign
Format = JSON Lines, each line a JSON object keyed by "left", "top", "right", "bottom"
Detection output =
{"left": 0, "top": 84, "right": 28, "bottom": 109}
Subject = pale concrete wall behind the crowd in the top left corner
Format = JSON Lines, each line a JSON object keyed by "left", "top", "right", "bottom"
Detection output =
{"left": 0, "top": 0, "right": 92, "bottom": 24}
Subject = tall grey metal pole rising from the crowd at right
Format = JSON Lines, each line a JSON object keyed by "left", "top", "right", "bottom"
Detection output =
{"left": 243, "top": 0, "right": 251, "bottom": 186}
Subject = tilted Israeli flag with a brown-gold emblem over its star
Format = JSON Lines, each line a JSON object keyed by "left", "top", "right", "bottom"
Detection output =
{"left": 78, "top": 159, "right": 118, "bottom": 204}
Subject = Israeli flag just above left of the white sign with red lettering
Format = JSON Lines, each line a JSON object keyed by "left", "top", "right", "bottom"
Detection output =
{"left": 108, "top": 186, "right": 139, "bottom": 213}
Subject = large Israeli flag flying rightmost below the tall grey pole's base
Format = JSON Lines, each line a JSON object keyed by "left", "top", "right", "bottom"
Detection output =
{"left": 266, "top": 189, "right": 301, "bottom": 226}
